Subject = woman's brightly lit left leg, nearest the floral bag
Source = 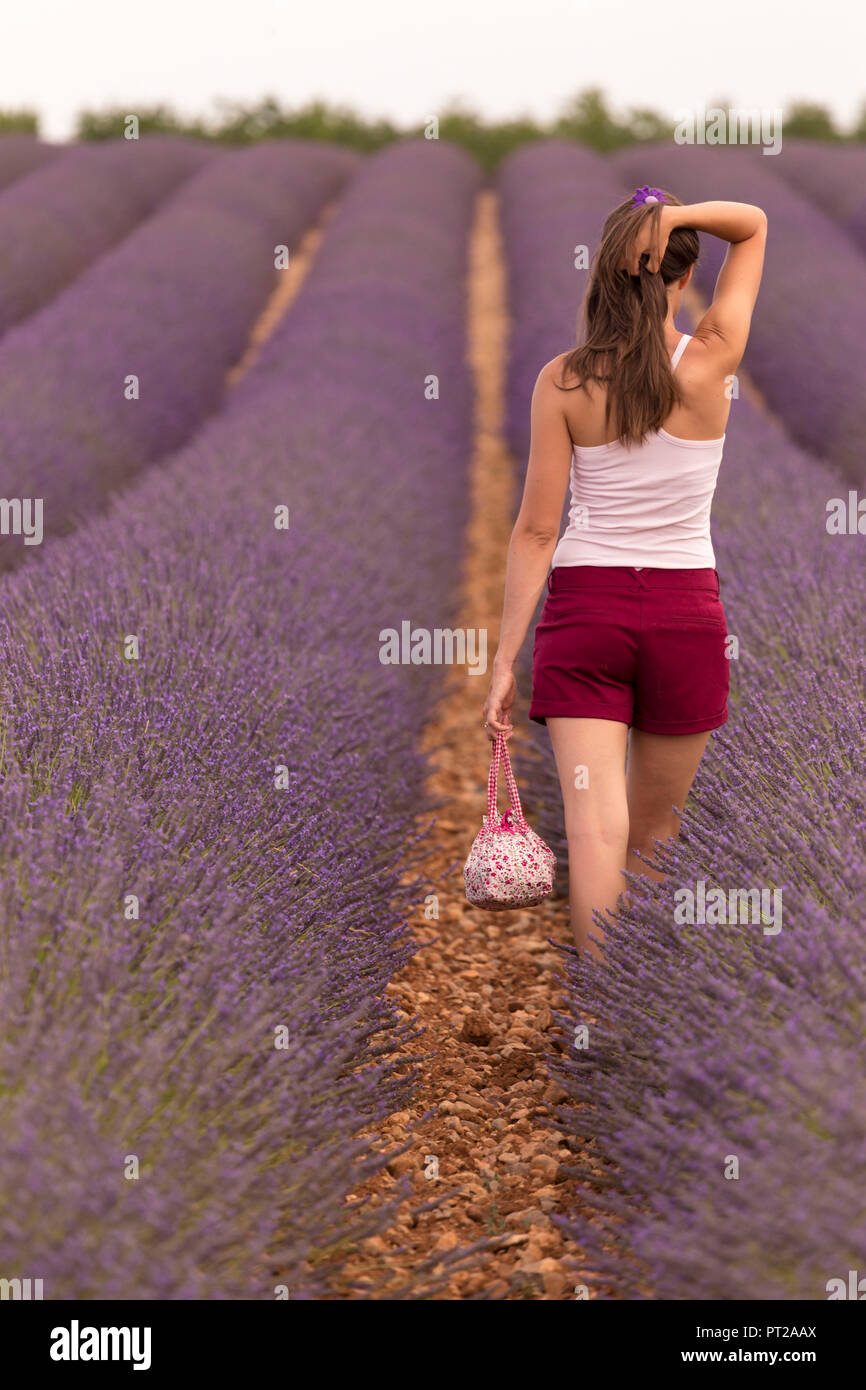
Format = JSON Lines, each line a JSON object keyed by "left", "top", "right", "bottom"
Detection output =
{"left": 548, "top": 719, "right": 628, "bottom": 959}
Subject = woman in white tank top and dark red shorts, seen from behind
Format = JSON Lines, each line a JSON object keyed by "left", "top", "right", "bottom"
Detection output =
{"left": 484, "top": 188, "right": 767, "bottom": 956}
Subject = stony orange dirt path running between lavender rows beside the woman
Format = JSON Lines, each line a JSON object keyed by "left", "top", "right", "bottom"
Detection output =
{"left": 335, "top": 192, "right": 573, "bottom": 1300}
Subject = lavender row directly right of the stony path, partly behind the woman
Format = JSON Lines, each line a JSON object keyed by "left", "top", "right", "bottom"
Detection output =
{"left": 500, "top": 135, "right": 866, "bottom": 1300}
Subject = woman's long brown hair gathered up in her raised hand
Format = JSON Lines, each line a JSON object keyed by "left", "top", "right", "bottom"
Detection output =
{"left": 556, "top": 189, "right": 701, "bottom": 443}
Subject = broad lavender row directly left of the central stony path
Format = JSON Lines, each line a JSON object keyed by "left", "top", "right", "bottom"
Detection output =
{"left": 0, "top": 142, "right": 480, "bottom": 1298}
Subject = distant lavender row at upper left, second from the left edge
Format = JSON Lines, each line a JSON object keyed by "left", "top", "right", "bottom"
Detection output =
{"left": 0, "top": 136, "right": 217, "bottom": 334}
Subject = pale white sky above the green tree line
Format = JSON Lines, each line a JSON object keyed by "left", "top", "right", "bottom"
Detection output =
{"left": 0, "top": 0, "right": 866, "bottom": 139}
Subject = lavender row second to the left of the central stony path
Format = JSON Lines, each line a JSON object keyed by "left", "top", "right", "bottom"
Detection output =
{"left": 0, "top": 140, "right": 359, "bottom": 558}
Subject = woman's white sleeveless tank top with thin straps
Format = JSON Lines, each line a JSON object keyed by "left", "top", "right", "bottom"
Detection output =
{"left": 552, "top": 334, "right": 724, "bottom": 570}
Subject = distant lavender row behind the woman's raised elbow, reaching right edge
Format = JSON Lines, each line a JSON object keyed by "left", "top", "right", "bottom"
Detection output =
{"left": 612, "top": 145, "right": 866, "bottom": 482}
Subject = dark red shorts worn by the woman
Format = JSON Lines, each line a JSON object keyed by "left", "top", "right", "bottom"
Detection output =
{"left": 530, "top": 564, "right": 731, "bottom": 734}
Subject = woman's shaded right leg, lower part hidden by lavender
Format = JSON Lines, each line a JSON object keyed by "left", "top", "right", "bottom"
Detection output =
{"left": 626, "top": 728, "right": 710, "bottom": 883}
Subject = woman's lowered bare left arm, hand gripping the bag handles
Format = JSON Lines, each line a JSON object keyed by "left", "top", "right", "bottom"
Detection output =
{"left": 484, "top": 359, "right": 571, "bottom": 737}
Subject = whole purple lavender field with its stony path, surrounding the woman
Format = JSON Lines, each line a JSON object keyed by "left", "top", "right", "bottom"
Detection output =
{"left": 0, "top": 136, "right": 866, "bottom": 1301}
